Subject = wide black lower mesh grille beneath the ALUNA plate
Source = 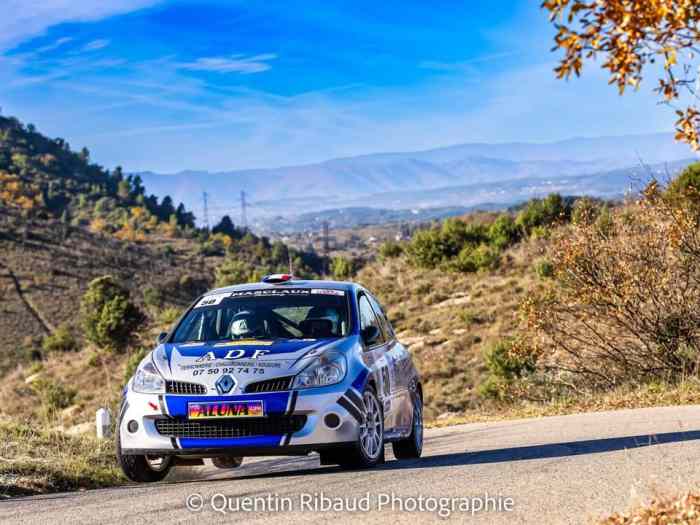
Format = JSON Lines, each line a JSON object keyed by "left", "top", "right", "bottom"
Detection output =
{"left": 156, "top": 415, "right": 306, "bottom": 438}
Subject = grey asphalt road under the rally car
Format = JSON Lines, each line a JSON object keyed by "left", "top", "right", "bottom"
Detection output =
{"left": 0, "top": 406, "right": 700, "bottom": 525}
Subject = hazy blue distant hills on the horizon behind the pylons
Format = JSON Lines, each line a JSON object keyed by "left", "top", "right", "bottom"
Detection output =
{"left": 139, "top": 133, "right": 695, "bottom": 226}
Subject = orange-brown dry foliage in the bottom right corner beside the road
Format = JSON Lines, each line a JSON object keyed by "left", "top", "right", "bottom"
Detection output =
{"left": 599, "top": 491, "right": 700, "bottom": 525}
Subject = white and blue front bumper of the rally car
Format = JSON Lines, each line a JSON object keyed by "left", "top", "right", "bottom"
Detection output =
{"left": 118, "top": 385, "right": 361, "bottom": 456}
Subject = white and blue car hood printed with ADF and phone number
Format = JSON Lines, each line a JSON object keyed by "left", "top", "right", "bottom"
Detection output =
{"left": 153, "top": 338, "right": 352, "bottom": 395}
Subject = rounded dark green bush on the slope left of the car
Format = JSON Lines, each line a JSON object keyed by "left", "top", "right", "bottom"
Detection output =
{"left": 80, "top": 275, "right": 144, "bottom": 350}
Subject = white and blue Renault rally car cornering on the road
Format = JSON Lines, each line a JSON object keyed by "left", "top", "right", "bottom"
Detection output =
{"left": 116, "top": 274, "right": 423, "bottom": 482}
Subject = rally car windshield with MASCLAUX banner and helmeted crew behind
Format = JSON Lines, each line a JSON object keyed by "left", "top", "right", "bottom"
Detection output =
{"left": 172, "top": 288, "right": 348, "bottom": 343}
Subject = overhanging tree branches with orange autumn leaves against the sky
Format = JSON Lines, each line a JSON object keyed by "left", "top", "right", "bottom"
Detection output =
{"left": 542, "top": 0, "right": 700, "bottom": 150}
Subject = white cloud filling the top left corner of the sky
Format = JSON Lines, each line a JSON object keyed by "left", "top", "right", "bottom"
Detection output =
{"left": 0, "top": 0, "right": 159, "bottom": 51}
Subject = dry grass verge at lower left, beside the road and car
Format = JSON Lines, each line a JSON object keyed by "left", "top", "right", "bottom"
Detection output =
{"left": 0, "top": 419, "right": 125, "bottom": 498}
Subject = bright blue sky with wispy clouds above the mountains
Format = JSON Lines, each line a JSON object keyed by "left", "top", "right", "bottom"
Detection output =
{"left": 0, "top": 0, "right": 673, "bottom": 172}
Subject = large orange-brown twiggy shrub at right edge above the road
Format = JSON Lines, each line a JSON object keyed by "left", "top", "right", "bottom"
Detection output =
{"left": 522, "top": 183, "right": 700, "bottom": 388}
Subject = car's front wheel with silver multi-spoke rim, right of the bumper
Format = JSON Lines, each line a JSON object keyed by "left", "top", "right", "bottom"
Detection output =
{"left": 334, "top": 386, "right": 384, "bottom": 469}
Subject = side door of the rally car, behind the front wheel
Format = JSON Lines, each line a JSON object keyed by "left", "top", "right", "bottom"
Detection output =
{"left": 357, "top": 291, "right": 394, "bottom": 431}
